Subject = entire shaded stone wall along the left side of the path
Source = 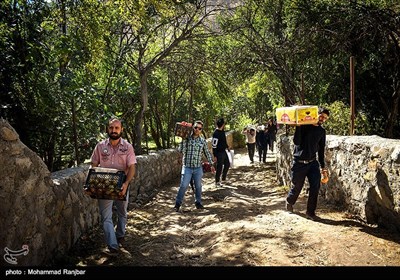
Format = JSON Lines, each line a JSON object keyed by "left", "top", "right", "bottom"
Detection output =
{"left": 0, "top": 119, "right": 235, "bottom": 266}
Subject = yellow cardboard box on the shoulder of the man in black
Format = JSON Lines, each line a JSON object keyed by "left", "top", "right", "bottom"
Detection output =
{"left": 276, "top": 105, "right": 318, "bottom": 125}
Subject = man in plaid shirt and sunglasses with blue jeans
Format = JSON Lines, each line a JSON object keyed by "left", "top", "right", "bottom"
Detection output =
{"left": 174, "top": 120, "right": 214, "bottom": 212}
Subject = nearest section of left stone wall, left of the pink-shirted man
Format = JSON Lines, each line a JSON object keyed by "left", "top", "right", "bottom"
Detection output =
{"left": 0, "top": 119, "right": 99, "bottom": 265}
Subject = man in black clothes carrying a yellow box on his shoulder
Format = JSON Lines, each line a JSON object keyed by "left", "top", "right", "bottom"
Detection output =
{"left": 286, "top": 108, "right": 329, "bottom": 220}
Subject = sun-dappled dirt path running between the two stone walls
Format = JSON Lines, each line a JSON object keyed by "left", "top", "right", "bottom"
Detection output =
{"left": 63, "top": 150, "right": 400, "bottom": 266}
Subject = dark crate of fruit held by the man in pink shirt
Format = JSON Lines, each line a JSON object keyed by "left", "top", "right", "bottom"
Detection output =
{"left": 84, "top": 167, "right": 126, "bottom": 201}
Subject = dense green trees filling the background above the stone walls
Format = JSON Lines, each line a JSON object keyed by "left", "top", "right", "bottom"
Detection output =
{"left": 0, "top": 0, "right": 400, "bottom": 171}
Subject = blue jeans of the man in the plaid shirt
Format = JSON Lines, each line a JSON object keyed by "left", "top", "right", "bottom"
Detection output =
{"left": 175, "top": 166, "right": 203, "bottom": 205}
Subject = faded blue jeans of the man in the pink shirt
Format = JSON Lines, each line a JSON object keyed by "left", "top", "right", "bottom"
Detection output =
{"left": 98, "top": 190, "right": 129, "bottom": 249}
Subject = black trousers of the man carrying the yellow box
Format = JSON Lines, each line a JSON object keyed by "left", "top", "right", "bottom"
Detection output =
{"left": 286, "top": 160, "right": 321, "bottom": 215}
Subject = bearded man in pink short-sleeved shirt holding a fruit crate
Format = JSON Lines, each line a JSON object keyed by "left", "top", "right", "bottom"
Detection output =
{"left": 91, "top": 118, "right": 136, "bottom": 255}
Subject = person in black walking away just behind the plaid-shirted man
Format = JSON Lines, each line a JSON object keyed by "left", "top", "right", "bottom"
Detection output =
{"left": 211, "top": 118, "right": 230, "bottom": 186}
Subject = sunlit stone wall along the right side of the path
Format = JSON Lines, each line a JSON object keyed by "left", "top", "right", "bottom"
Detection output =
{"left": 276, "top": 135, "right": 400, "bottom": 232}
